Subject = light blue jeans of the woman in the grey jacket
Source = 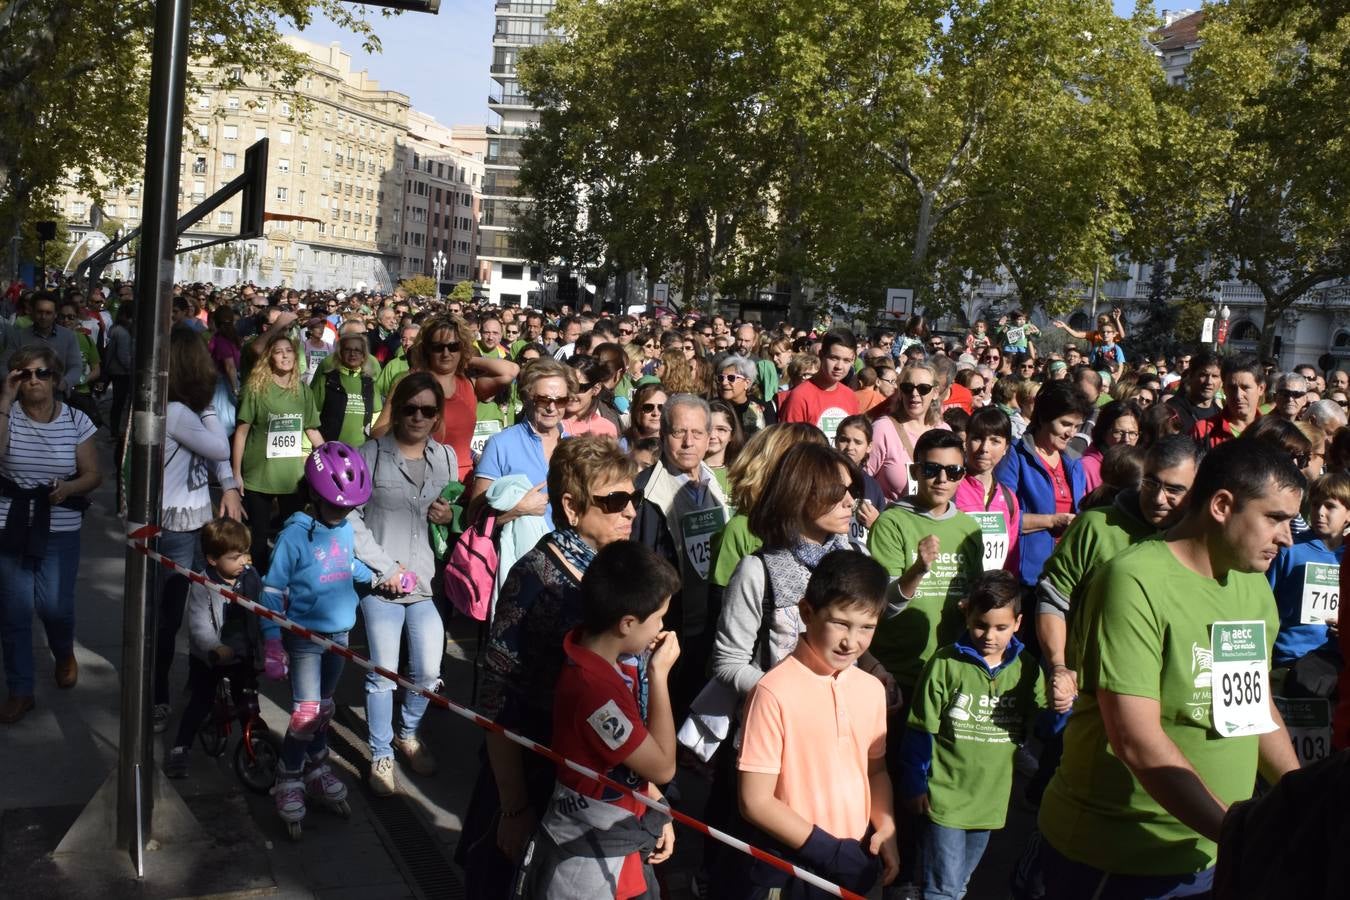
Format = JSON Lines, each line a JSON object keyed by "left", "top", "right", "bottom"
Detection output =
{"left": 360, "top": 595, "right": 446, "bottom": 760}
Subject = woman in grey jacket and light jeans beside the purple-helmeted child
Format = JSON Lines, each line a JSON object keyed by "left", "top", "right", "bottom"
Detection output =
{"left": 347, "top": 372, "right": 459, "bottom": 796}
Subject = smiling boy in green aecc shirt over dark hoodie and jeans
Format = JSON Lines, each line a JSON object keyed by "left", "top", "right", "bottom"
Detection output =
{"left": 899, "top": 569, "right": 1045, "bottom": 900}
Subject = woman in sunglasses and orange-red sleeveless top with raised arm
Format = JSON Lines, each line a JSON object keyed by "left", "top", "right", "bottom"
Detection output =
{"left": 370, "top": 316, "right": 520, "bottom": 480}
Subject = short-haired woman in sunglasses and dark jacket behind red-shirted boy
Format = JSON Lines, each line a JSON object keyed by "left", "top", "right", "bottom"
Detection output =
{"left": 458, "top": 436, "right": 641, "bottom": 897}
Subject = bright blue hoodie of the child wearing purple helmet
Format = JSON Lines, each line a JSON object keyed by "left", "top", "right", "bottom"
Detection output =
{"left": 262, "top": 513, "right": 375, "bottom": 640}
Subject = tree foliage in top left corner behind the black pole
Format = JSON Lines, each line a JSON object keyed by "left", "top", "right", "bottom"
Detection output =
{"left": 0, "top": 0, "right": 379, "bottom": 277}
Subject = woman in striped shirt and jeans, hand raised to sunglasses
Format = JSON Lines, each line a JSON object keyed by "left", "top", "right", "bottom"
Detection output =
{"left": 0, "top": 345, "right": 103, "bottom": 725}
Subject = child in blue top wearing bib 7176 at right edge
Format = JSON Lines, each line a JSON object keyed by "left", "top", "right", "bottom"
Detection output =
{"left": 1266, "top": 472, "right": 1350, "bottom": 667}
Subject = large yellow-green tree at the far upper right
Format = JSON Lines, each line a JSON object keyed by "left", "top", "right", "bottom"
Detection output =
{"left": 1152, "top": 0, "right": 1350, "bottom": 354}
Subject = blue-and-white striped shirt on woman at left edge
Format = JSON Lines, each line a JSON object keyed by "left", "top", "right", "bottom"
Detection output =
{"left": 0, "top": 403, "right": 97, "bottom": 532}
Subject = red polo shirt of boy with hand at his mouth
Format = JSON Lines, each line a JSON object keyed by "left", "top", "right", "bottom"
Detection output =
{"left": 554, "top": 629, "right": 648, "bottom": 900}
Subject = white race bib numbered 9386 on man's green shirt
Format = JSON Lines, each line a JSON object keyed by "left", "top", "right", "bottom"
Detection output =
{"left": 1210, "top": 622, "right": 1276, "bottom": 738}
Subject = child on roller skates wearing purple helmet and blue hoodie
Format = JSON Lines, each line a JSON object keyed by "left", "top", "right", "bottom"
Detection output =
{"left": 262, "top": 441, "right": 380, "bottom": 837}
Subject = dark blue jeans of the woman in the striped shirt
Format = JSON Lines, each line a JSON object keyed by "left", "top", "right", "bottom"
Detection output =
{"left": 0, "top": 530, "right": 80, "bottom": 696}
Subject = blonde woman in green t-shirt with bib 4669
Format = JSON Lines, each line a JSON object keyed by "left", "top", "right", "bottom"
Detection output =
{"left": 231, "top": 329, "right": 324, "bottom": 573}
